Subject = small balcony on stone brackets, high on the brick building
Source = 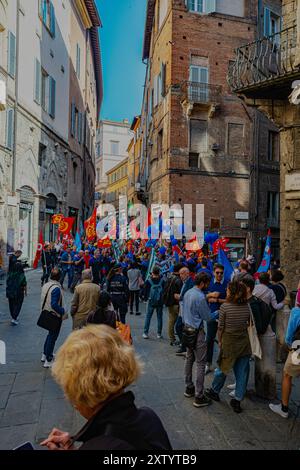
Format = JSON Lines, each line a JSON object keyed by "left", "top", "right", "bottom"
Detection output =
{"left": 181, "top": 82, "right": 222, "bottom": 117}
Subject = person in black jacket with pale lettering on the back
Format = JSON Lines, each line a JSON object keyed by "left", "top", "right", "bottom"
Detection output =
{"left": 107, "top": 263, "right": 129, "bottom": 324}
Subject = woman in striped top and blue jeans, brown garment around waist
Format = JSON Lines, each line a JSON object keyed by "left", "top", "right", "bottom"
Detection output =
{"left": 205, "top": 281, "right": 252, "bottom": 413}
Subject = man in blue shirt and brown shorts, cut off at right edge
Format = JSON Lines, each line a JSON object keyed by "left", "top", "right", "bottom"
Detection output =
{"left": 269, "top": 302, "right": 300, "bottom": 418}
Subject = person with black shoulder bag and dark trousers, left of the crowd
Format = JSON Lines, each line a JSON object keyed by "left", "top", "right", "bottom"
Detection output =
{"left": 41, "top": 268, "right": 66, "bottom": 368}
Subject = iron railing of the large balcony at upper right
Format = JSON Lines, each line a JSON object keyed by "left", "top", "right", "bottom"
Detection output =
{"left": 228, "top": 26, "right": 299, "bottom": 92}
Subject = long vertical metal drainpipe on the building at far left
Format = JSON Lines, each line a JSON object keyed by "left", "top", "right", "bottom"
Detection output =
{"left": 11, "top": 0, "right": 20, "bottom": 194}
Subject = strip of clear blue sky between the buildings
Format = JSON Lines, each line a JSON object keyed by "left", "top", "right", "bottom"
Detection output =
{"left": 96, "top": 0, "right": 146, "bottom": 121}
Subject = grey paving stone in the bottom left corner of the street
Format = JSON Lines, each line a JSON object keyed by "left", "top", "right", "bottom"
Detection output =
{"left": 0, "top": 424, "right": 36, "bottom": 450}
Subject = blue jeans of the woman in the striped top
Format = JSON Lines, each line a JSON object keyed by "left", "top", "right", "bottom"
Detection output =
{"left": 211, "top": 356, "right": 251, "bottom": 401}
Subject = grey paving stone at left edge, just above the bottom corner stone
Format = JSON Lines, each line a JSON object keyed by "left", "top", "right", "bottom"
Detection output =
{"left": 0, "top": 392, "right": 42, "bottom": 427}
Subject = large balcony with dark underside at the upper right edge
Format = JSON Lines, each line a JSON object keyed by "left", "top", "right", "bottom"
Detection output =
{"left": 228, "top": 26, "right": 300, "bottom": 100}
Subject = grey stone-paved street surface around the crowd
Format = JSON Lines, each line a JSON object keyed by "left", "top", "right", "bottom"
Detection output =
{"left": 0, "top": 271, "right": 300, "bottom": 450}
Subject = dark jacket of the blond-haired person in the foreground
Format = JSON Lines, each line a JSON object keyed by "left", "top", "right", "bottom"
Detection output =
{"left": 72, "top": 392, "right": 172, "bottom": 450}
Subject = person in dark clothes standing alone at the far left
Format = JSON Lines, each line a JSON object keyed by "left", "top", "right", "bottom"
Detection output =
{"left": 6, "top": 250, "right": 27, "bottom": 326}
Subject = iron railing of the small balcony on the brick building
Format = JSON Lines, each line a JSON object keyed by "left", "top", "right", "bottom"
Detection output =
{"left": 182, "top": 82, "right": 222, "bottom": 104}
